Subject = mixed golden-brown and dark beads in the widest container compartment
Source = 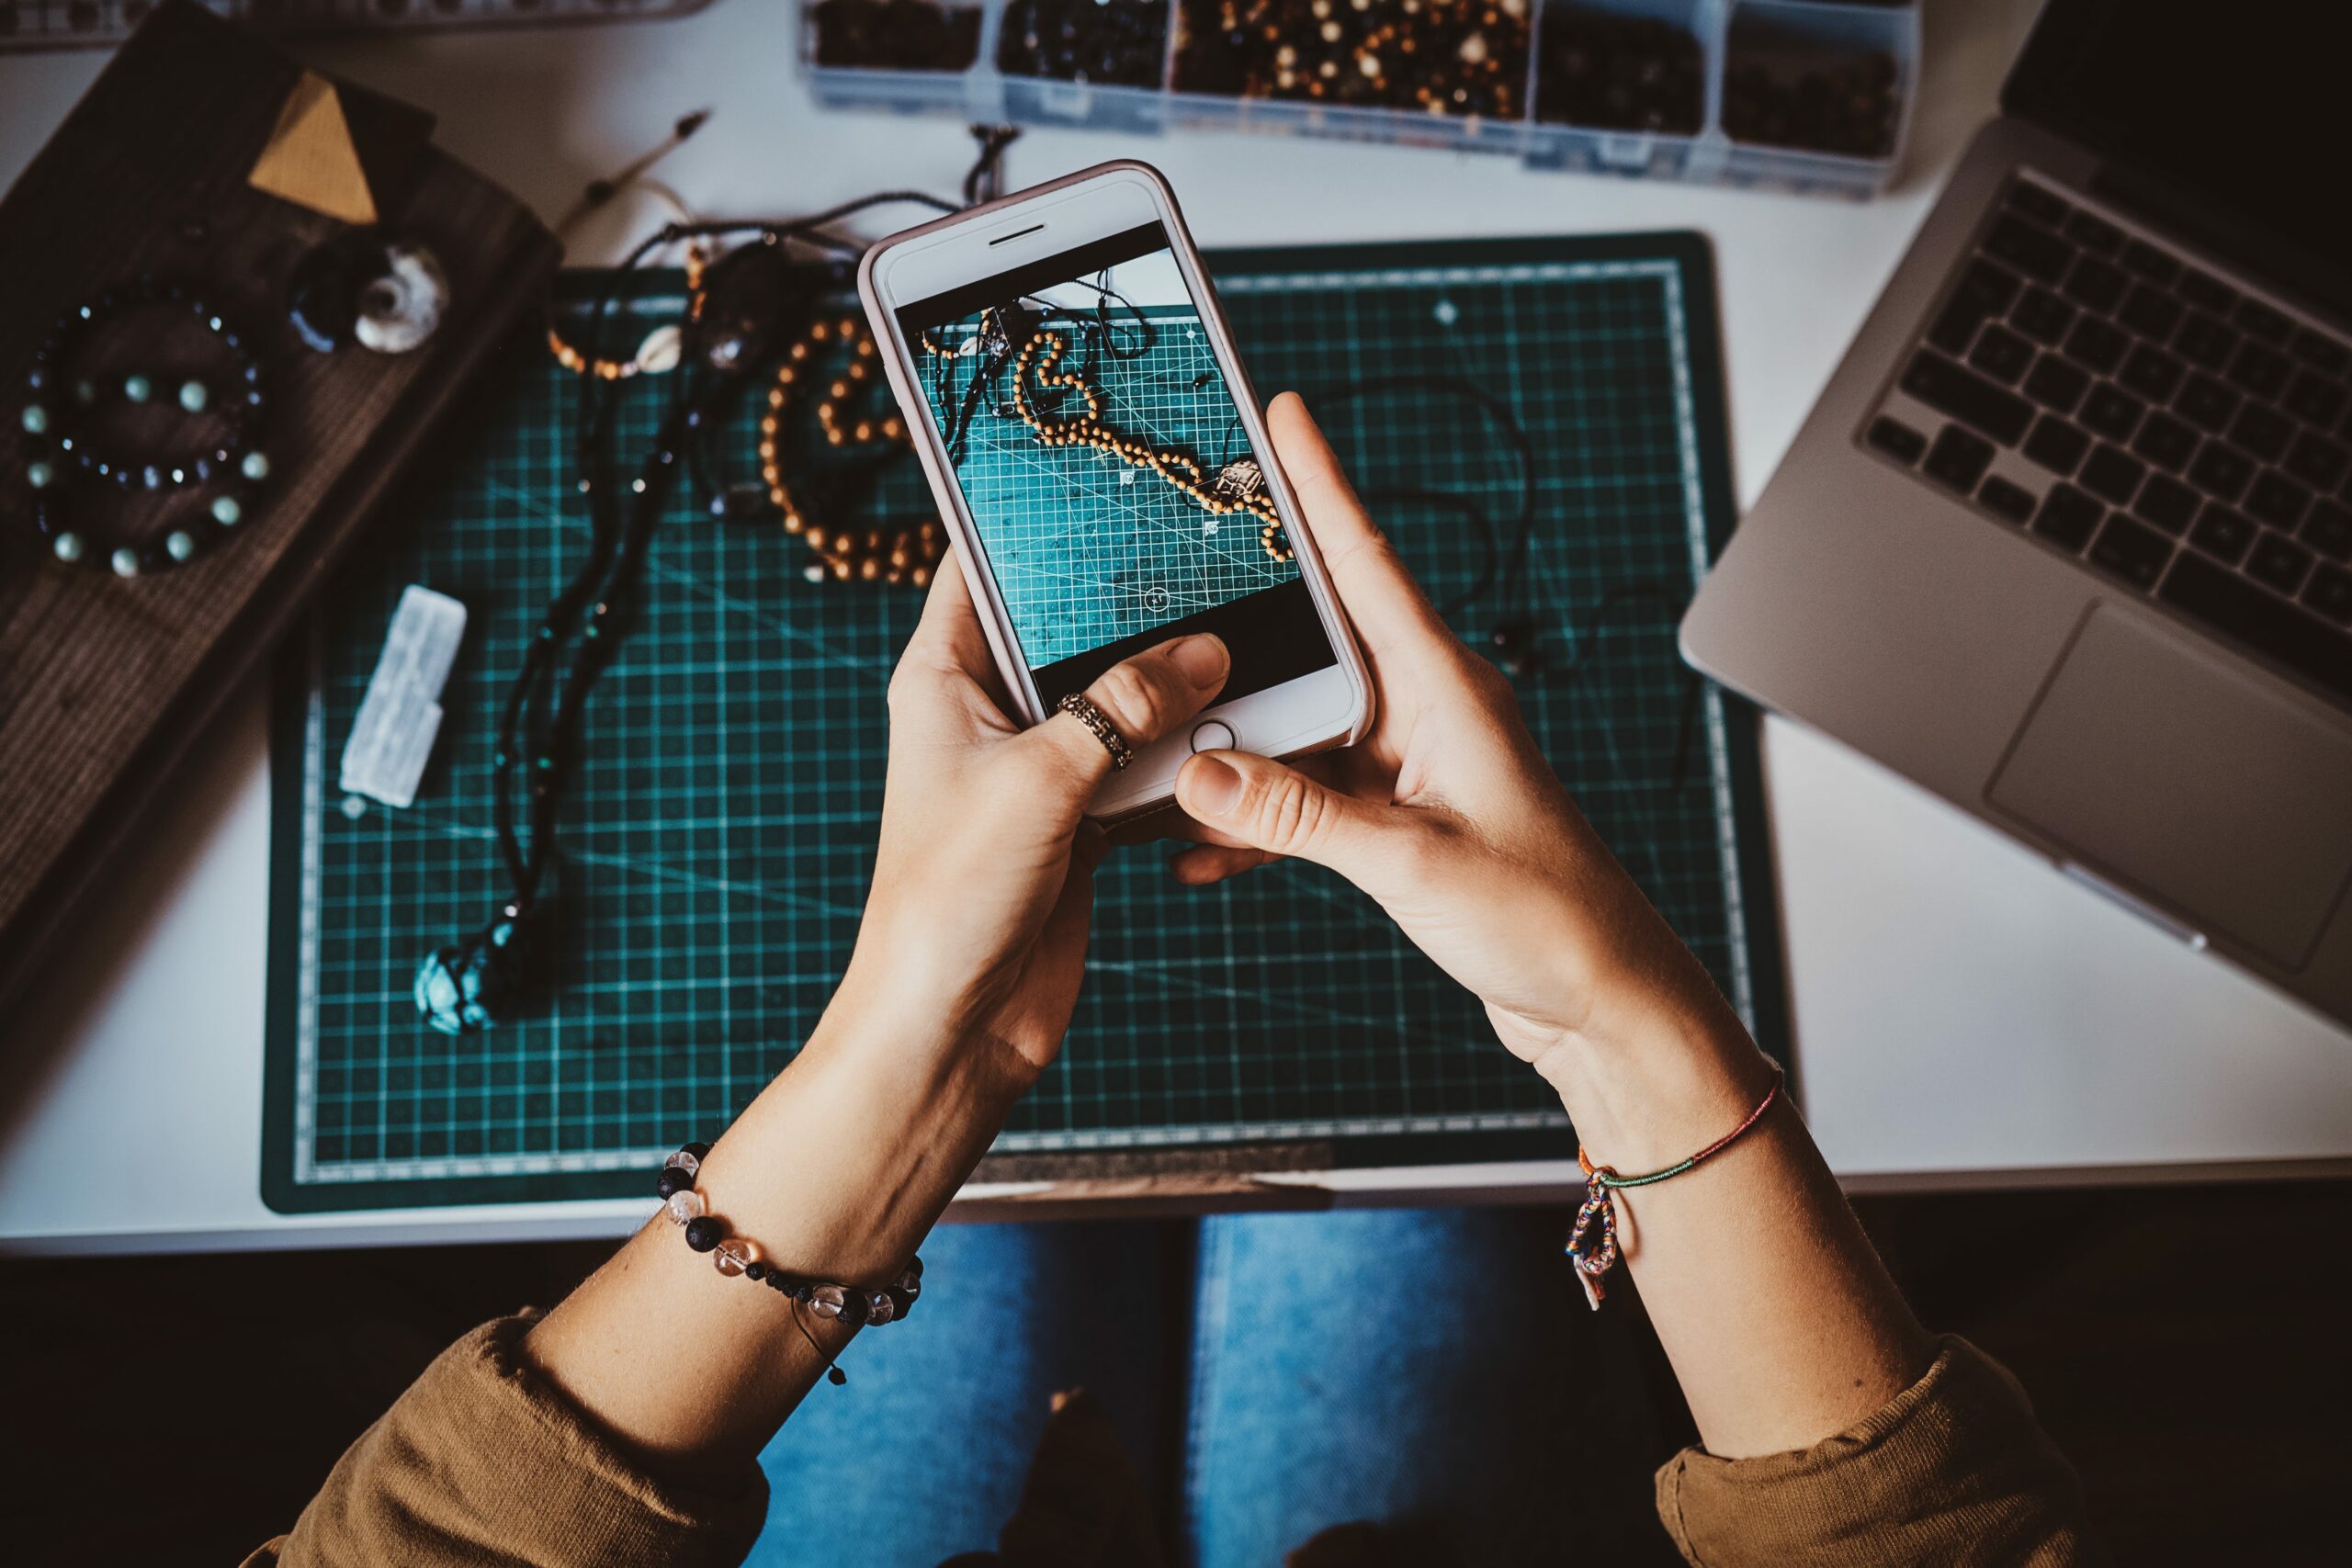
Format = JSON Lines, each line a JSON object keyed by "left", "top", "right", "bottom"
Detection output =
{"left": 1173, "top": 0, "right": 1532, "bottom": 120}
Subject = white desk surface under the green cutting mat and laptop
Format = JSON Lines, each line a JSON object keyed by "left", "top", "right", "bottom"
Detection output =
{"left": 0, "top": 0, "right": 2352, "bottom": 1251}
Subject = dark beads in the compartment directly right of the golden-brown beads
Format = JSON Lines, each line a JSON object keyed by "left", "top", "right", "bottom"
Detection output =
{"left": 1536, "top": 0, "right": 1708, "bottom": 136}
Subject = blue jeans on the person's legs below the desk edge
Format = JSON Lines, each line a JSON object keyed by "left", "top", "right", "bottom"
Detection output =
{"left": 752, "top": 1208, "right": 1687, "bottom": 1568}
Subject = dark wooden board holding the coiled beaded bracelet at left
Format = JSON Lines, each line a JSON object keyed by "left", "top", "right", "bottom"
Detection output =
{"left": 0, "top": 0, "right": 558, "bottom": 1024}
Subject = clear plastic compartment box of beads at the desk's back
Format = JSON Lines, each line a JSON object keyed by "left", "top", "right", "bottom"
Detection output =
{"left": 802, "top": 0, "right": 1919, "bottom": 197}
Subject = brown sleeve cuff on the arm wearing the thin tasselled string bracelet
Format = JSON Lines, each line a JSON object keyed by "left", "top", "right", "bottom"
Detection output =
{"left": 1658, "top": 1337, "right": 2105, "bottom": 1568}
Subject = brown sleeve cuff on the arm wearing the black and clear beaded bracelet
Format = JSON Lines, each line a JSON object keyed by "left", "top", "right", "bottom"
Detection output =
{"left": 247, "top": 1312, "right": 767, "bottom": 1568}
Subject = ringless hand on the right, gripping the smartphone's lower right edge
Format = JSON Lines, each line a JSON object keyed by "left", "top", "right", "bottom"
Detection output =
{"left": 1173, "top": 392, "right": 1769, "bottom": 1168}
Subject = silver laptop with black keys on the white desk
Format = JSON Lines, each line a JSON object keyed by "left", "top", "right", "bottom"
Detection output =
{"left": 1681, "top": 0, "right": 2352, "bottom": 1022}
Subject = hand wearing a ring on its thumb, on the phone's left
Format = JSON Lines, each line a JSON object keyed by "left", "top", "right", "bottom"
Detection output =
{"left": 835, "top": 562, "right": 1230, "bottom": 1089}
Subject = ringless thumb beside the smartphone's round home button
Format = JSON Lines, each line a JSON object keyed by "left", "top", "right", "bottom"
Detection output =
{"left": 1176, "top": 752, "right": 1419, "bottom": 898}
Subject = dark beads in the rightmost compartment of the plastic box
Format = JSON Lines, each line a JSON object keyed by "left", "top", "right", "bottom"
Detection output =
{"left": 1722, "top": 3, "right": 1903, "bottom": 157}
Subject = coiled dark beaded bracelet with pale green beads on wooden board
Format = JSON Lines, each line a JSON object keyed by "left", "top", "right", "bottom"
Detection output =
{"left": 18, "top": 275, "right": 270, "bottom": 576}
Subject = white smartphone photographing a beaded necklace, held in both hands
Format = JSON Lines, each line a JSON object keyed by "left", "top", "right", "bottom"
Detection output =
{"left": 858, "top": 163, "right": 1371, "bottom": 820}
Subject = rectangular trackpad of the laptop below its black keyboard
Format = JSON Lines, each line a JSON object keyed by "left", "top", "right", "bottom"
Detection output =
{"left": 1985, "top": 606, "right": 2352, "bottom": 968}
